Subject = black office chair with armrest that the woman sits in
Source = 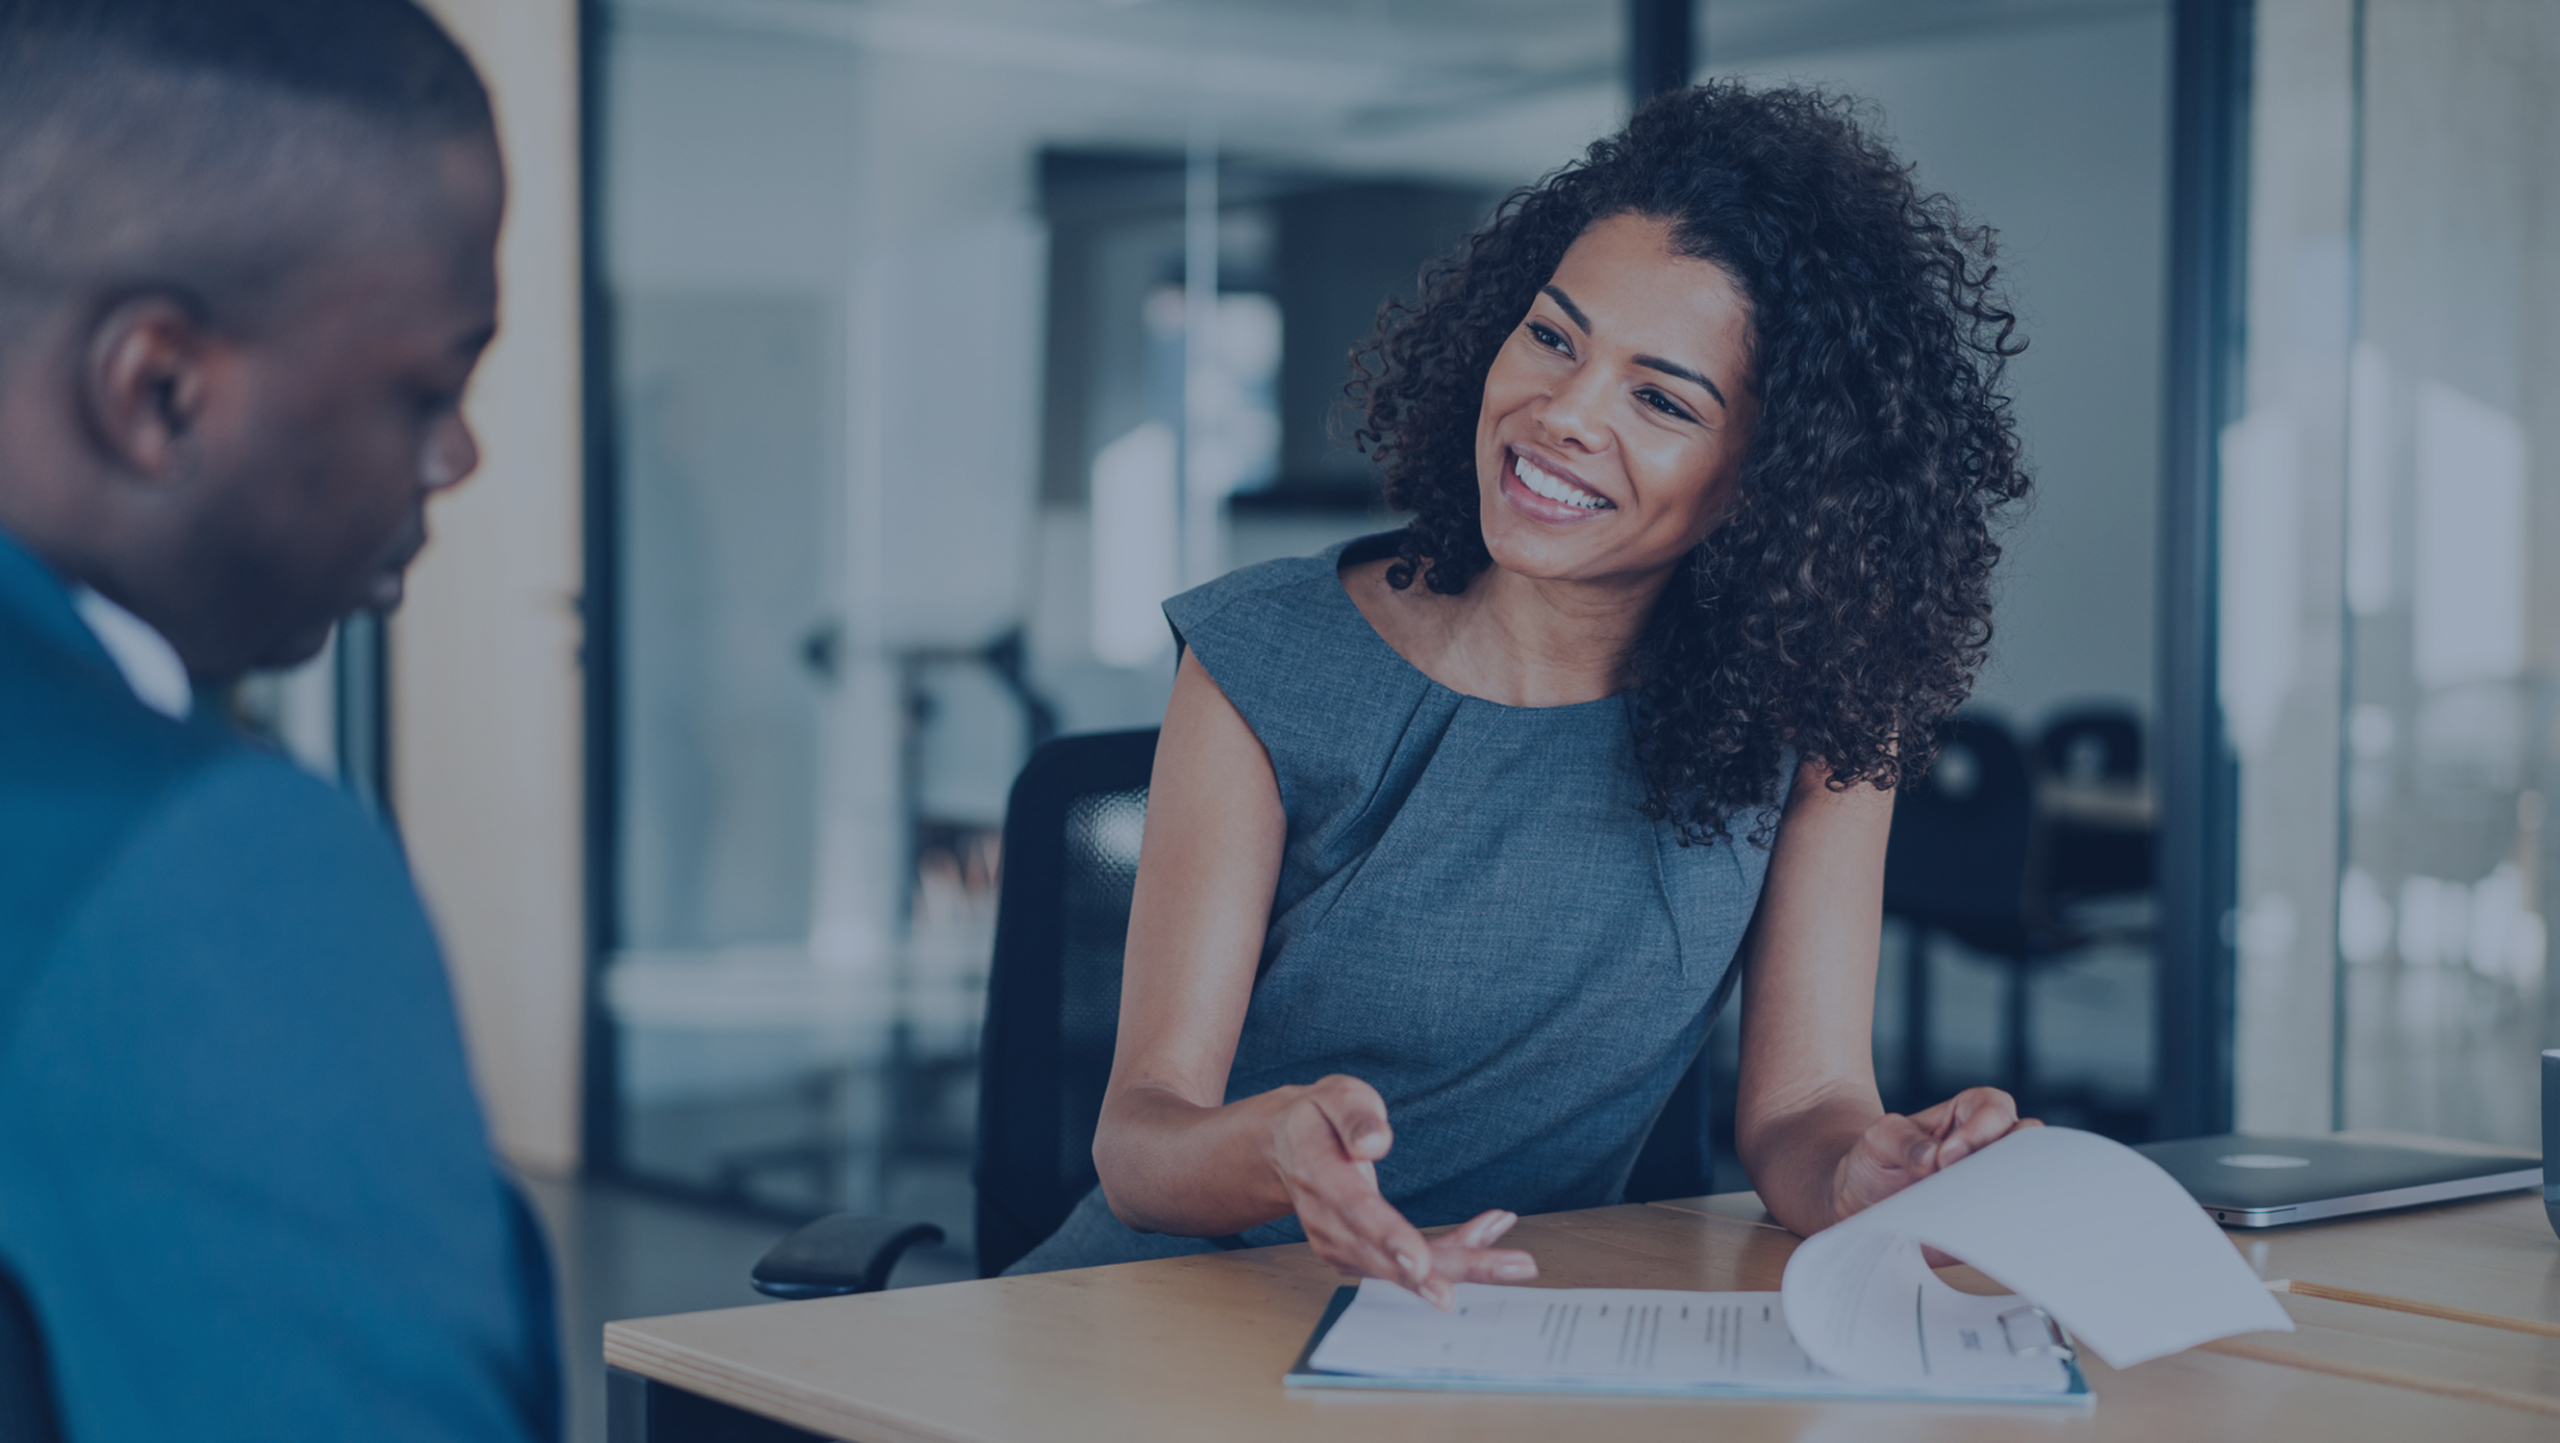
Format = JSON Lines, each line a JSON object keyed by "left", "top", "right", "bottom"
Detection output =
{"left": 753, "top": 729, "right": 1713, "bottom": 1297}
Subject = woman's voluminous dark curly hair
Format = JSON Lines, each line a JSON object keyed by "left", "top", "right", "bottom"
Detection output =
{"left": 1347, "top": 82, "right": 2028, "bottom": 844}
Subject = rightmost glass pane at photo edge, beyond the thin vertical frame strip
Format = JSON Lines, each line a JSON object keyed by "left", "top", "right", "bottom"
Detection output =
{"left": 2337, "top": 0, "right": 2560, "bottom": 1146}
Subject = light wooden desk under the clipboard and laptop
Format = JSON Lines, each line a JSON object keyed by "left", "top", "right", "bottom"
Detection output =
{"left": 604, "top": 1195, "right": 2560, "bottom": 1443}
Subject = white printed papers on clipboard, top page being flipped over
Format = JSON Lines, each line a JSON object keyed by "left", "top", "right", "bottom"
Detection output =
{"left": 1288, "top": 1128, "right": 2294, "bottom": 1407}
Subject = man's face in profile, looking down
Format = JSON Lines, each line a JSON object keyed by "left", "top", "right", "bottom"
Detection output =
{"left": 187, "top": 138, "right": 502, "bottom": 670}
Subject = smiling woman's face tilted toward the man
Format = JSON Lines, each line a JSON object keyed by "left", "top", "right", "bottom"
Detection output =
{"left": 1475, "top": 215, "right": 1759, "bottom": 581}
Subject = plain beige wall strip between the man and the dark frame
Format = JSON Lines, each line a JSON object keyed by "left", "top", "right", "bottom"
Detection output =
{"left": 392, "top": 0, "right": 586, "bottom": 1172}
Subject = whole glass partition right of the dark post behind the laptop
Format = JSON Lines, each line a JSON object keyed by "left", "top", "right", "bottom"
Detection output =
{"left": 2222, "top": 0, "right": 2560, "bottom": 1146}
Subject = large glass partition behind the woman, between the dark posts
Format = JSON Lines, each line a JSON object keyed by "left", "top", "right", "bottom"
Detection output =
{"left": 591, "top": 0, "right": 2168, "bottom": 1249}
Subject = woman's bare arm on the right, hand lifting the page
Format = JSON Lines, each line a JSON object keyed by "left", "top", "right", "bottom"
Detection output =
{"left": 1736, "top": 762, "right": 2033, "bottom": 1233}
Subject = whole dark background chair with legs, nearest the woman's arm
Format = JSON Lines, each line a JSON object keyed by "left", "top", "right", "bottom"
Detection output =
{"left": 1884, "top": 716, "right": 2071, "bottom": 1105}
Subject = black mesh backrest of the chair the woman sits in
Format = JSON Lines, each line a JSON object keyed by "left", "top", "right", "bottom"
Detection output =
{"left": 975, "top": 729, "right": 1155, "bottom": 1277}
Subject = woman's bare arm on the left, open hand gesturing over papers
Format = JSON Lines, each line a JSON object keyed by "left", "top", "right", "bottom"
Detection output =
{"left": 1093, "top": 655, "right": 1536, "bottom": 1302}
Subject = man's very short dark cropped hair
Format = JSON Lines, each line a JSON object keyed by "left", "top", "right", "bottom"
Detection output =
{"left": 0, "top": 0, "right": 492, "bottom": 342}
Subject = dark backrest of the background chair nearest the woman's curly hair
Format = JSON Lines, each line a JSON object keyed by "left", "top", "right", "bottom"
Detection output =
{"left": 1884, "top": 716, "right": 2035, "bottom": 954}
